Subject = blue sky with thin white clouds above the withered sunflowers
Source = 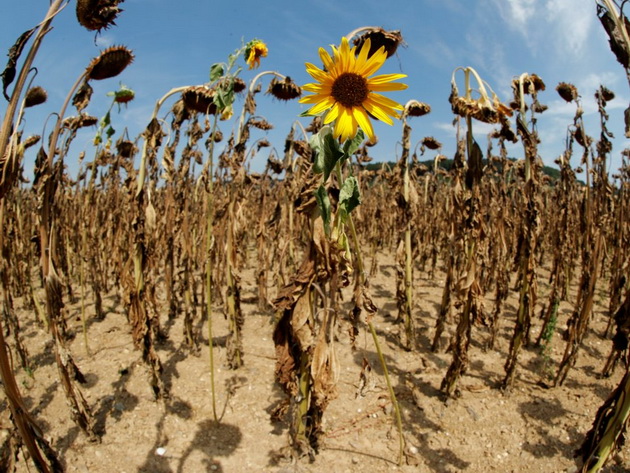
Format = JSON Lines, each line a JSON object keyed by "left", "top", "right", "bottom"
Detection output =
{"left": 0, "top": 0, "right": 630, "bottom": 177}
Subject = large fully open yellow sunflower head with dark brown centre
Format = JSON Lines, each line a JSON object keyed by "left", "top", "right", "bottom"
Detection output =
{"left": 300, "top": 38, "right": 407, "bottom": 141}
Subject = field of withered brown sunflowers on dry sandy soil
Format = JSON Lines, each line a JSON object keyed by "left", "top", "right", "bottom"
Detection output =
{"left": 0, "top": 0, "right": 630, "bottom": 473}
